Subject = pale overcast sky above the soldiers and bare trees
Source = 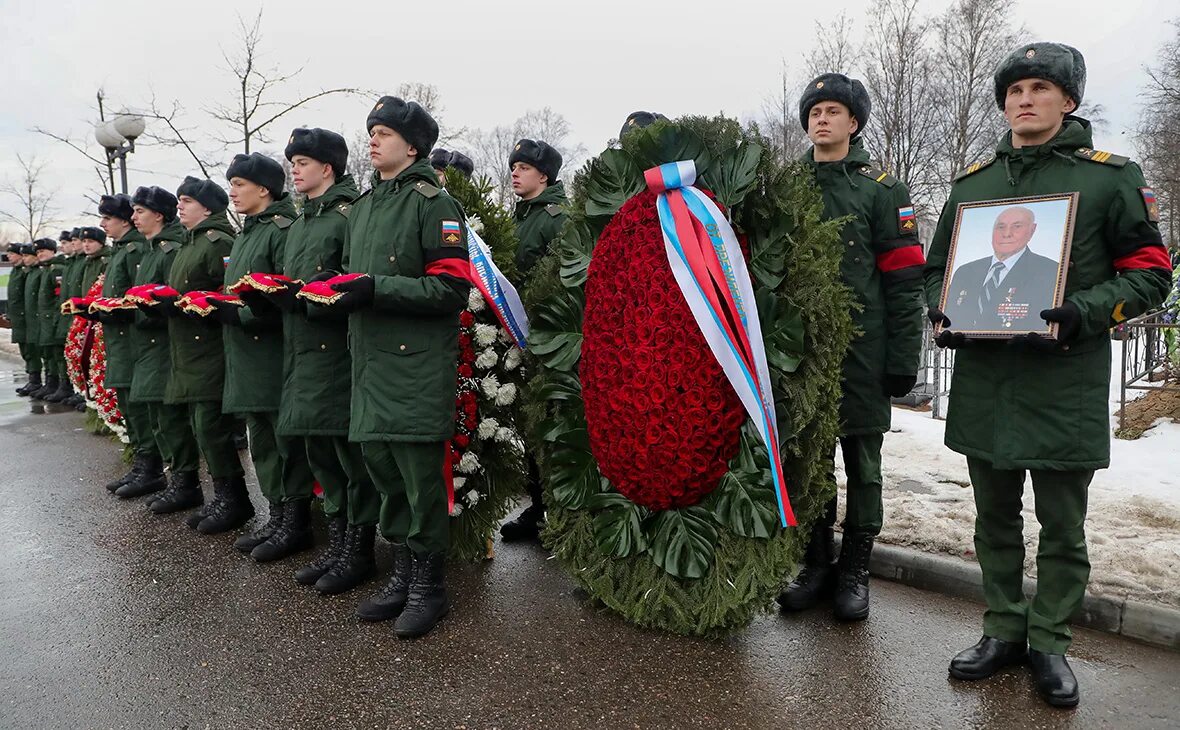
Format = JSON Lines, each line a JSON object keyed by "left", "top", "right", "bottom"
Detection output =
{"left": 0, "top": 0, "right": 1180, "bottom": 234}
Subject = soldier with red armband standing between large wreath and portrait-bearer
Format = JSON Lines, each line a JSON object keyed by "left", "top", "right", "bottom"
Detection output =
{"left": 779, "top": 73, "right": 925, "bottom": 620}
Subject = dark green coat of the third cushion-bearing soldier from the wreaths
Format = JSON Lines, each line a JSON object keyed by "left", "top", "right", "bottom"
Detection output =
{"left": 222, "top": 193, "right": 296, "bottom": 413}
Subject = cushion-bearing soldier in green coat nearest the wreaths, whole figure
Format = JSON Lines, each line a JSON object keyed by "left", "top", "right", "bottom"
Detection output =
{"left": 311, "top": 97, "right": 470, "bottom": 638}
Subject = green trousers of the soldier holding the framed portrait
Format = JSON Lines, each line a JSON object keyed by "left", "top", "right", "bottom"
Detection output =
{"left": 966, "top": 456, "right": 1094, "bottom": 655}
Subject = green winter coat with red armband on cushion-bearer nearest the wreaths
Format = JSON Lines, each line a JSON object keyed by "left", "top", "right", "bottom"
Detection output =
{"left": 343, "top": 160, "right": 470, "bottom": 442}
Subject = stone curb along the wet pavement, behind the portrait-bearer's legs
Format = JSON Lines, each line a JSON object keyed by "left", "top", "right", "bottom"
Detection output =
{"left": 835, "top": 534, "right": 1180, "bottom": 650}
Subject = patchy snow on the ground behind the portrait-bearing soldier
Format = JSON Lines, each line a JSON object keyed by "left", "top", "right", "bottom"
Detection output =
{"left": 837, "top": 342, "right": 1180, "bottom": 607}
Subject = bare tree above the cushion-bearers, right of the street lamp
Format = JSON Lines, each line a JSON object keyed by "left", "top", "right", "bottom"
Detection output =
{"left": 205, "top": 8, "right": 362, "bottom": 154}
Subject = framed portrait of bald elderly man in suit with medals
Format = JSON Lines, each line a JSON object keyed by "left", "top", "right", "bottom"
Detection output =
{"left": 940, "top": 192, "right": 1077, "bottom": 338}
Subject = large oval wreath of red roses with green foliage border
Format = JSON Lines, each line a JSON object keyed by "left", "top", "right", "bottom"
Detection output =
{"left": 525, "top": 118, "right": 852, "bottom": 634}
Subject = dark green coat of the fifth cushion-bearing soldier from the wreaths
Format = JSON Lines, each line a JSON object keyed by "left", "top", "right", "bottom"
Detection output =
{"left": 131, "top": 221, "right": 186, "bottom": 403}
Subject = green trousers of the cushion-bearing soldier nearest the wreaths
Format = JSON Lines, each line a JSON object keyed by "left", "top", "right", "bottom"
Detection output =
{"left": 361, "top": 441, "right": 451, "bottom": 553}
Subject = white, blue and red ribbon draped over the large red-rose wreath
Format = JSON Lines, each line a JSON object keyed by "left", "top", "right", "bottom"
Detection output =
{"left": 643, "top": 160, "right": 795, "bottom": 527}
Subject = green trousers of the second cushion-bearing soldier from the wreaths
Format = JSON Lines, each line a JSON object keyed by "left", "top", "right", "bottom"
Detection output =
{"left": 297, "top": 436, "right": 381, "bottom": 525}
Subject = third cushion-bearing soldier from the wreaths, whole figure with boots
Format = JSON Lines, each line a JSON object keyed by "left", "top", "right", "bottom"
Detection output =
{"left": 212, "top": 152, "right": 313, "bottom": 563}
